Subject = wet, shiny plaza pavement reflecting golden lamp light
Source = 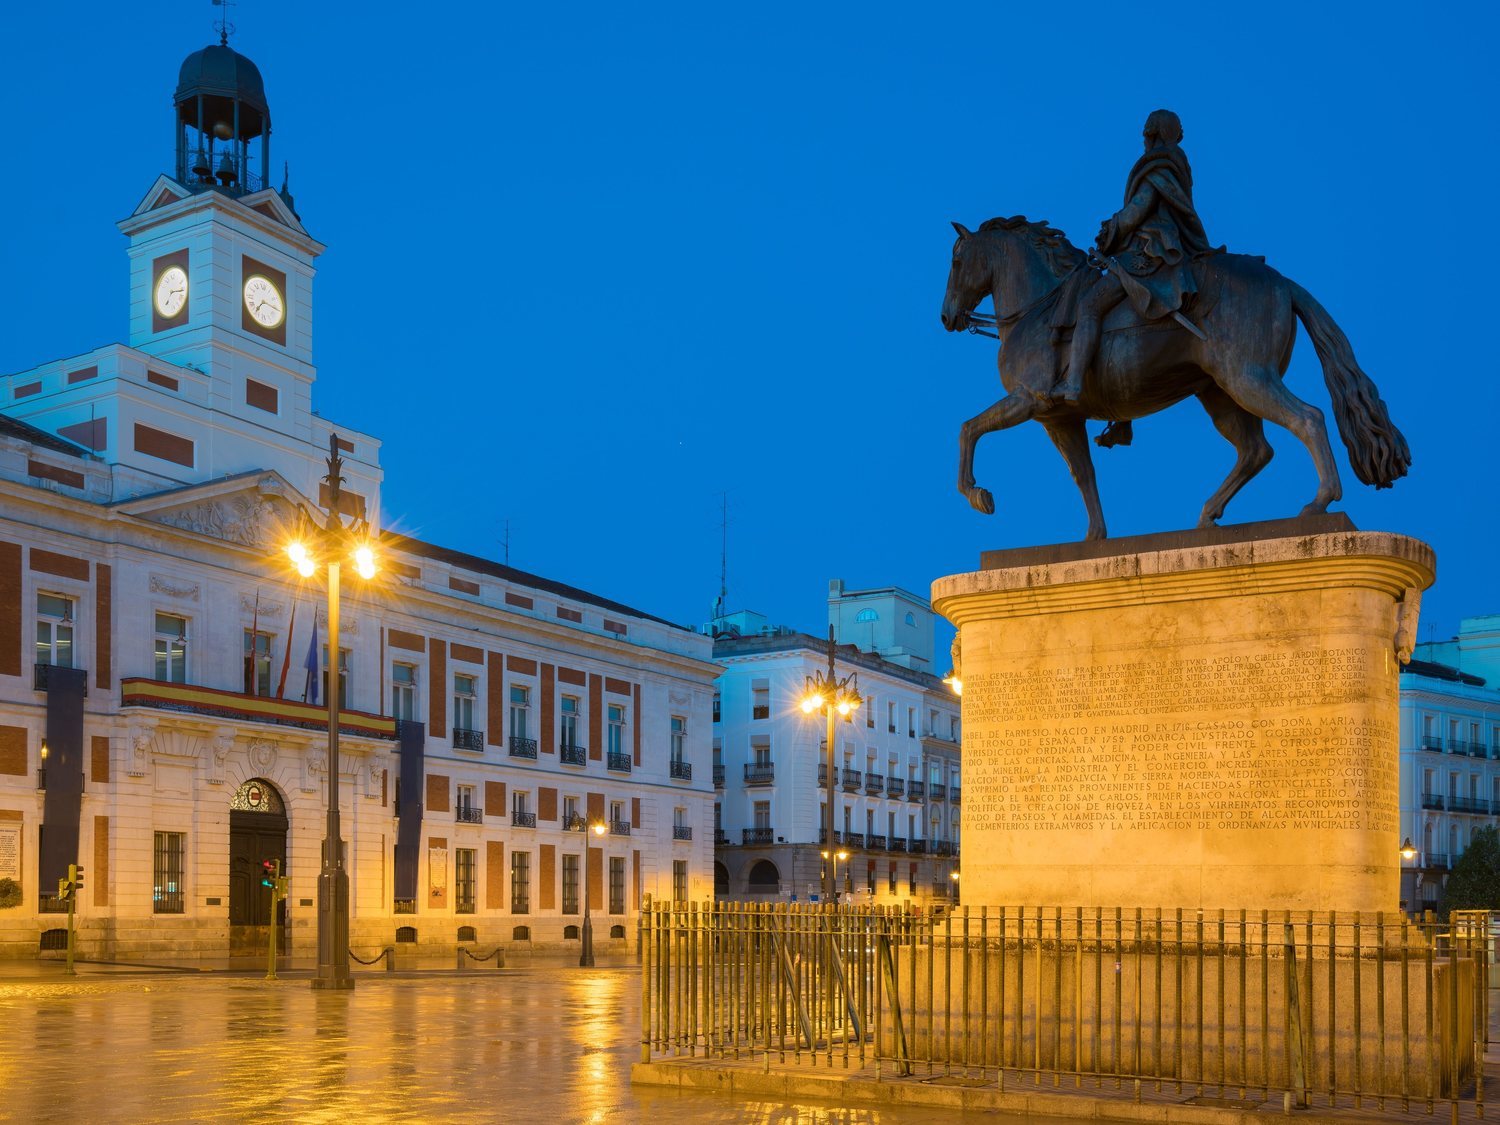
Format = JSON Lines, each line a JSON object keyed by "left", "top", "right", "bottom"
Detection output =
{"left": 0, "top": 963, "right": 1020, "bottom": 1125}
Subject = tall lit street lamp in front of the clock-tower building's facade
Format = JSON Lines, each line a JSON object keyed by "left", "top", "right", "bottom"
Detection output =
{"left": 287, "top": 434, "right": 375, "bottom": 990}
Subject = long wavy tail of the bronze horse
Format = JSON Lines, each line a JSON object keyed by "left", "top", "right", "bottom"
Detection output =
{"left": 1289, "top": 282, "right": 1412, "bottom": 489}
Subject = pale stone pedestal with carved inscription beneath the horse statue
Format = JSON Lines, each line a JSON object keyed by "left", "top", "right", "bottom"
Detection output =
{"left": 933, "top": 516, "right": 1436, "bottom": 914}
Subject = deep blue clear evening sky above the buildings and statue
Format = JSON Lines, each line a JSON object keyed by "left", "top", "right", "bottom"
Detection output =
{"left": 0, "top": 0, "right": 1500, "bottom": 651}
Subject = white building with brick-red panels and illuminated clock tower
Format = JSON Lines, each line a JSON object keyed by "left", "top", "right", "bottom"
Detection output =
{"left": 0, "top": 37, "right": 719, "bottom": 959}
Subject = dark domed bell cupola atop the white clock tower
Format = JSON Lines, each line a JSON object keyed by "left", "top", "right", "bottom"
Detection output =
{"left": 173, "top": 32, "right": 272, "bottom": 195}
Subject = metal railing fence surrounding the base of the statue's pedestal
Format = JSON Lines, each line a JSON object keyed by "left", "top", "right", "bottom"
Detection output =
{"left": 641, "top": 902, "right": 1491, "bottom": 1113}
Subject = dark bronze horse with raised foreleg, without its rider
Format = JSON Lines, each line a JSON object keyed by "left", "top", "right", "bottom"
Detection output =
{"left": 942, "top": 216, "right": 1412, "bottom": 539}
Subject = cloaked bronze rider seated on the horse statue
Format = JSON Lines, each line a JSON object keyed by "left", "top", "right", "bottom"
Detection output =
{"left": 1052, "top": 110, "right": 1214, "bottom": 405}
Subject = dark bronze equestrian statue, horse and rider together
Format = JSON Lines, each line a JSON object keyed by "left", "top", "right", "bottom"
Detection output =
{"left": 942, "top": 110, "right": 1412, "bottom": 539}
